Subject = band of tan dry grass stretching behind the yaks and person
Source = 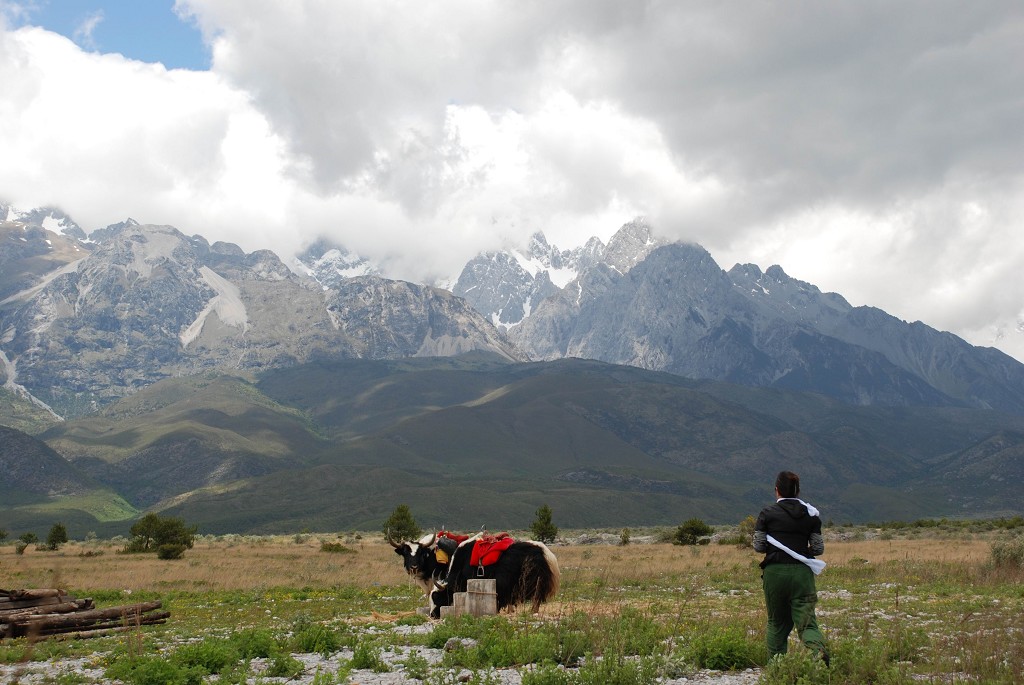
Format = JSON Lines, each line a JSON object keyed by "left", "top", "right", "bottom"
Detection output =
{"left": 0, "top": 536, "right": 990, "bottom": 592}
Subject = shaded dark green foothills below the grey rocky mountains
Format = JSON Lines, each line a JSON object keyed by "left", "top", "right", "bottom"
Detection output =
{"left": 6, "top": 354, "right": 1024, "bottom": 534}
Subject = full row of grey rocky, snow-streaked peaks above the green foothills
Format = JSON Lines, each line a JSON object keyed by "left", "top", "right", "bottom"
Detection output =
{"left": 6, "top": 197, "right": 1024, "bottom": 416}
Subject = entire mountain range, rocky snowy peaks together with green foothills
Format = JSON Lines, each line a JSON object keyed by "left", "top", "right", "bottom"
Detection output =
{"left": 0, "top": 204, "right": 1024, "bottom": 531}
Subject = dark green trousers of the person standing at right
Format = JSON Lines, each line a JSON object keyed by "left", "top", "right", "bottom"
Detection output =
{"left": 761, "top": 563, "right": 827, "bottom": 658}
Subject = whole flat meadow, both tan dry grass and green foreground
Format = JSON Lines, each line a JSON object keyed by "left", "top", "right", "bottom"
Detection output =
{"left": 0, "top": 525, "right": 1024, "bottom": 685}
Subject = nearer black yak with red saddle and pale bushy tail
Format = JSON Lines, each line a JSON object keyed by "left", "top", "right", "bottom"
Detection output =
{"left": 430, "top": 538, "right": 561, "bottom": 618}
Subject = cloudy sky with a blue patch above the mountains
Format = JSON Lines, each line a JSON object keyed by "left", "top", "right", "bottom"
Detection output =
{"left": 0, "top": 0, "right": 1024, "bottom": 359}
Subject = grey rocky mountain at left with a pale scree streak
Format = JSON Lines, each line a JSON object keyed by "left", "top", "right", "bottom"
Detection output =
{"left": 0, "top": 221, "right": 521, "bottom": 416}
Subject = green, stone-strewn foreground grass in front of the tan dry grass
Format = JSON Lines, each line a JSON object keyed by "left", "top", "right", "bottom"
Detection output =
{"left": 0, "top": 533, "right": 1024, "bottom": 685}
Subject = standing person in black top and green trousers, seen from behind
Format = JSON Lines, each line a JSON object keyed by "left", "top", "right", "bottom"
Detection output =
{"left": 754, "top": 471, "right": 828, "bottom": 663}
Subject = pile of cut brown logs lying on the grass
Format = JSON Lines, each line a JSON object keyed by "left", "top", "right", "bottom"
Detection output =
{"left": 0, "top": 589, "right": 171, "bottom": 639}
